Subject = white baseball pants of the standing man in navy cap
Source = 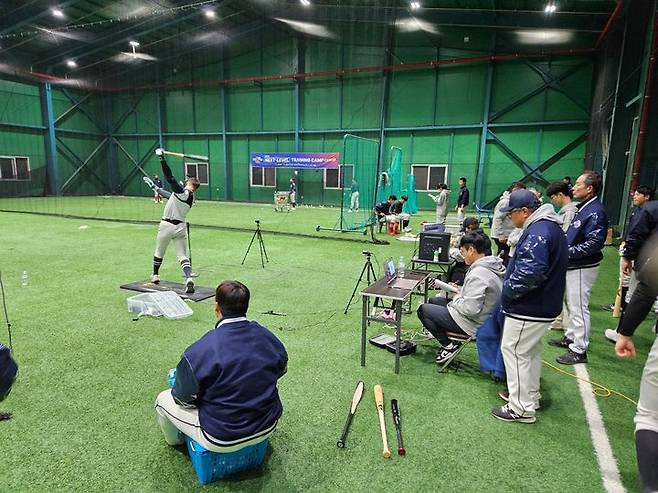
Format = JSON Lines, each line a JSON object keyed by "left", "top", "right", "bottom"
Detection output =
{"left": 501, "top": 316, "right": 551, "bottom": 416}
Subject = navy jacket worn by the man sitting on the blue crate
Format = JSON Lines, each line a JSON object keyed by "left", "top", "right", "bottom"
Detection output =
{"left": 172, "top": 316, "right": 288, "bottom": 446}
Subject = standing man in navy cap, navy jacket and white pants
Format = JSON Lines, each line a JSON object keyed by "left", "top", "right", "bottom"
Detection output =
{"left": 491, "top": 190, "right": 567, "bottom": 423}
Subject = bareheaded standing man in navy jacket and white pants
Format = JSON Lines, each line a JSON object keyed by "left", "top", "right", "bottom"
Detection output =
{"left": 549, "top": 171, "right": 608, "bottom": 365}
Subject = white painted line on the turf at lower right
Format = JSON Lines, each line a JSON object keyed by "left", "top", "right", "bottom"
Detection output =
{"left": 574, "top": 364, "right": 626, "bottom": 493}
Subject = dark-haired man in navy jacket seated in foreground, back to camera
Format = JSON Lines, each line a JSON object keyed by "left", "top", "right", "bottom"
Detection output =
{"left": 155, "top": 281, "right": 288, "bottom": 452}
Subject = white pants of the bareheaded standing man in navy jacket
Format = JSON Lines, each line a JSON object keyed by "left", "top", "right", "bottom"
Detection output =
{"left": 564, "top": 265, "right": 599, "bottom": 354}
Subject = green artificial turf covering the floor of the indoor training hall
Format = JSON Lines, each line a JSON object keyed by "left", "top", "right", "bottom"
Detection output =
{"left": 0, "top": 199, "right": 653, "bottom": 492}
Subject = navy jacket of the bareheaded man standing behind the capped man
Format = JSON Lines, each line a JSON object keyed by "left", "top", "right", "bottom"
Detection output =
{"left": 567, "top": 197, "right": 608, "bottom": 270}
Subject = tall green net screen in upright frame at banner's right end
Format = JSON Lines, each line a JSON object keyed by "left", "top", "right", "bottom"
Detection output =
{"left": 336, "top": 135, "right": 379, "bottom": 231}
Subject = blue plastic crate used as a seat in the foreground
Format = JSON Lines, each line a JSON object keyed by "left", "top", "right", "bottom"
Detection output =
{"left": 185, "top": 436, "right": 270, "bottom": 484}
